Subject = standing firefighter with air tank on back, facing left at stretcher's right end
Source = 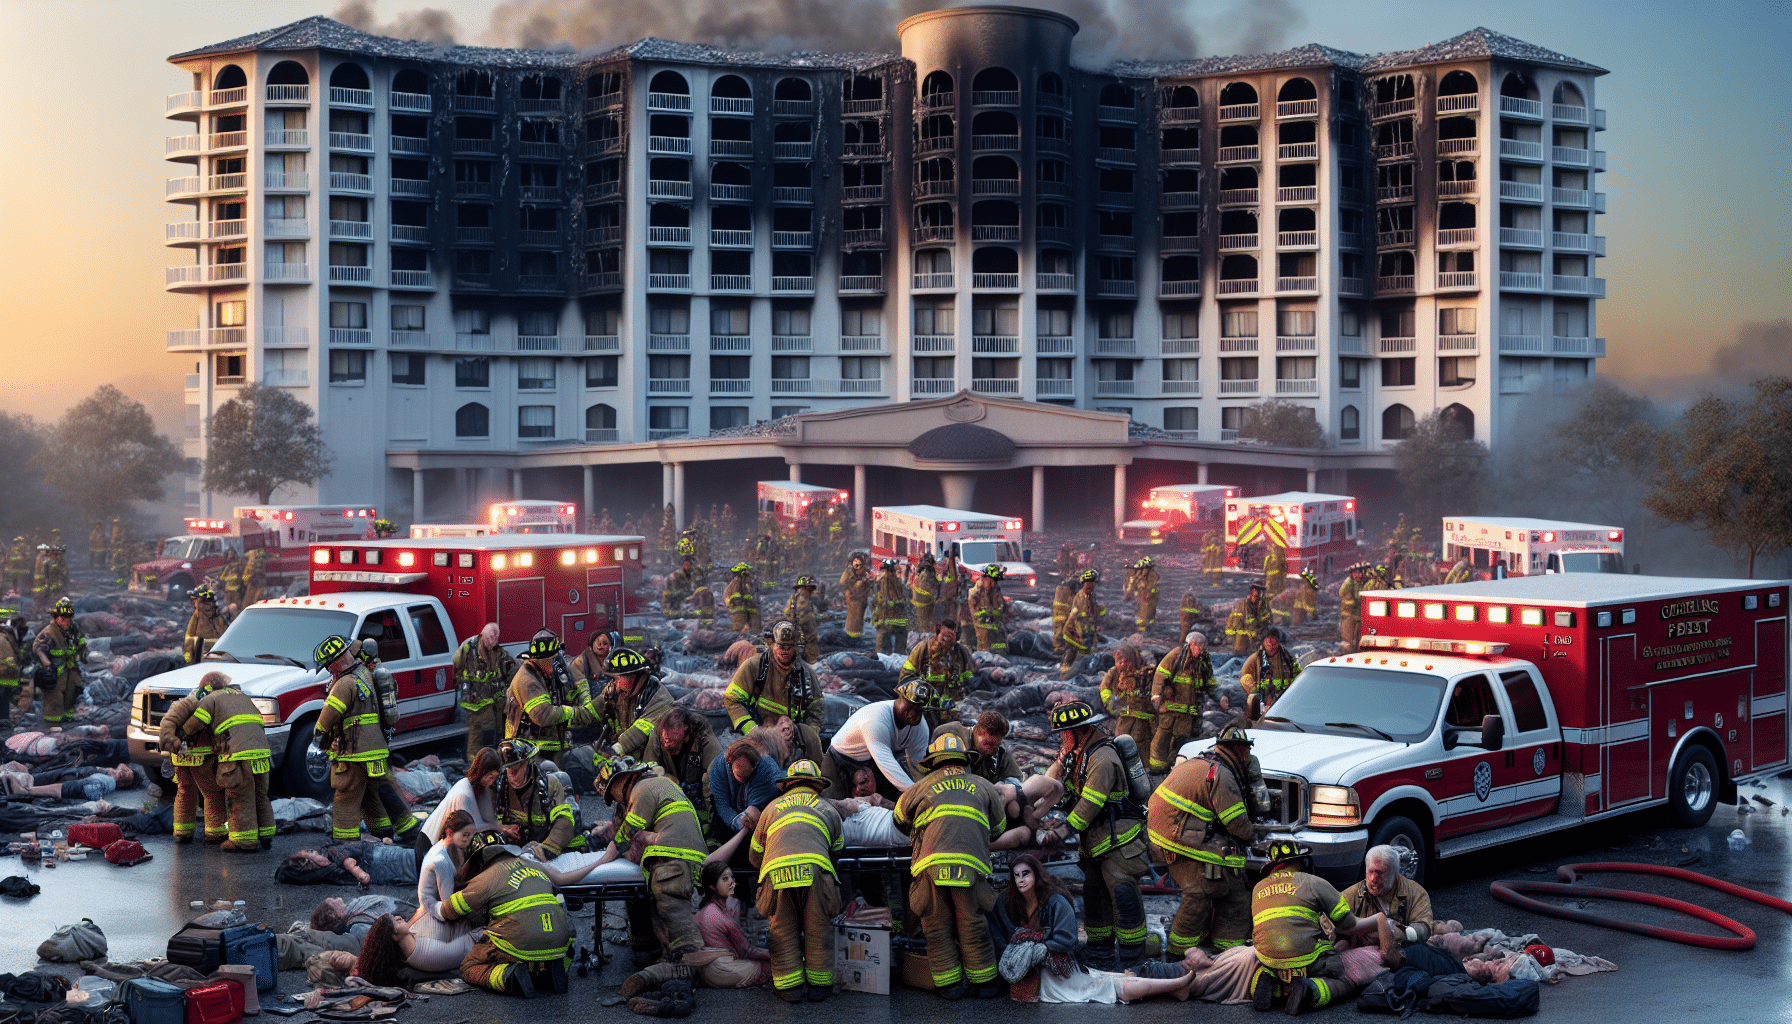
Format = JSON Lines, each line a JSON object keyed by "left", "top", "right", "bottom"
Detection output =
{"left": 1047, "top": 701, "right": 1150, "bottom": 970}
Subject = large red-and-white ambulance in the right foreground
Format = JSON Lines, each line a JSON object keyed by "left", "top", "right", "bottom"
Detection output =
{"left": 1183, "top": 572, "right": 1788, "bottom": 881}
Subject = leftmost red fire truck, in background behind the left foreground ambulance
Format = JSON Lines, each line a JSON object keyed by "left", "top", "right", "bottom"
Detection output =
{"left": 127, "top": 506, "right": 380, "bottom": 601}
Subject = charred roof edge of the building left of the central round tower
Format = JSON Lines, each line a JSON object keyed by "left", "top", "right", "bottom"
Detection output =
{"left": 168, "top": 14, "right": 901, "bottom": 72}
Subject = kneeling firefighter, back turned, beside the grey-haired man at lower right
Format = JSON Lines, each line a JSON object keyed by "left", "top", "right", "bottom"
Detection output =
{"left": 1251, "top": 839, "right": 1382, "bottom": 1013}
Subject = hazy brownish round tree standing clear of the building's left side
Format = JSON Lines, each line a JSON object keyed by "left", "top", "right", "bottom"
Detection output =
{"left": 34, "top": 384, "right": 181, "bottom": 522}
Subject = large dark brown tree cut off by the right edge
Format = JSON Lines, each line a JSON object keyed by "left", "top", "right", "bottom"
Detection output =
{"left": 1643, "top": 377, "right": 1792, "bottom": 579}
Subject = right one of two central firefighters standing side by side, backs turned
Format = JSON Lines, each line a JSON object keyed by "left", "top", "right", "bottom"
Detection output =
{"left": 894, "top": 732, "right": 1010, "bottom": 999}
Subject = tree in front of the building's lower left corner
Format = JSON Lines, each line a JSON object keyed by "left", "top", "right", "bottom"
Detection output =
{"left": 204, "top": 384, "right": 333, "bottom": 504}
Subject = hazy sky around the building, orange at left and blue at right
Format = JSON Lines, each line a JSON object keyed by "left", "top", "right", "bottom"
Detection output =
{"left": 0, "top": 0, "right": 1792, "bottom": 429}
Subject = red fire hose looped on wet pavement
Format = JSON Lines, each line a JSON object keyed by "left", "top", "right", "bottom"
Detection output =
{"left": 1489, "top": 861, "right": 1792, "bottom": 949}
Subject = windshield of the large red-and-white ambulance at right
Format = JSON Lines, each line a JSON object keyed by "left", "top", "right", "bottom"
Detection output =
{"left": 1265, "top": 665, "right": 1444, "bottom": 742}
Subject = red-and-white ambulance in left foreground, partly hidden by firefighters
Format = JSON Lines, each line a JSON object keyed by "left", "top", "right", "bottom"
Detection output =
{"left": 125, "top": 534, "right": 643, "bottom": 802}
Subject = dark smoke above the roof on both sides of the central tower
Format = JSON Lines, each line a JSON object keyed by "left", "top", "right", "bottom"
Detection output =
{"left": 484, "top": 0, "right": 1305, "bottom": 66}
